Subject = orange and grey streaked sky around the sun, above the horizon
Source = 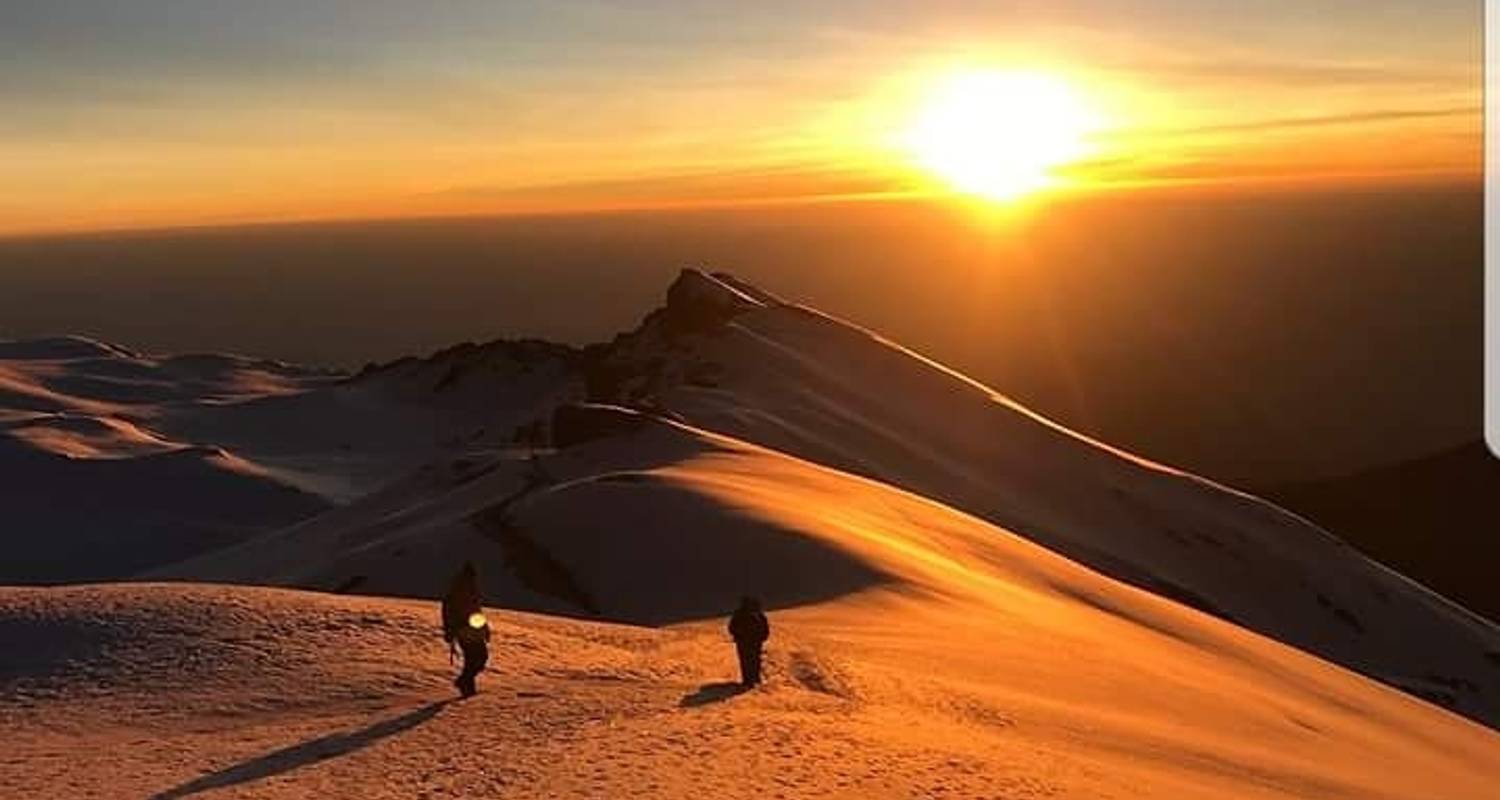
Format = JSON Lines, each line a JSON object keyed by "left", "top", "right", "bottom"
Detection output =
{"left": 0, "top": 0, "right": 1482, "bottom": 234}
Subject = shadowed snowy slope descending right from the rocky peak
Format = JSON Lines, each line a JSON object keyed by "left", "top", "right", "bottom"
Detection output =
{"left": 576, "top": 270, "right": 1500, "bottom": 725}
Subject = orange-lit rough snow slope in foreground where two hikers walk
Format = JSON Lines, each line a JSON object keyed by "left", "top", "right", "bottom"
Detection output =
{"left": 0, "top": 570, "right": 1500, "bottom": 800}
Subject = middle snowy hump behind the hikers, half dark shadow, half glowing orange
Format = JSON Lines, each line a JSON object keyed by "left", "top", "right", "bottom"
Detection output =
{"left": 147, "top": 396, "right": 1500, "bottom": 744}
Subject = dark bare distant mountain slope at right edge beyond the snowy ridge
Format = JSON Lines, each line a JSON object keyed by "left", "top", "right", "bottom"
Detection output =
{"left": 1263, "top": 441, "right": 1500, "bottom": 620}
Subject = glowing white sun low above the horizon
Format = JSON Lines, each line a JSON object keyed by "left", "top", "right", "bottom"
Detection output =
{"left": 906, "top": 71, "right": 1100, "bottom": 201}
